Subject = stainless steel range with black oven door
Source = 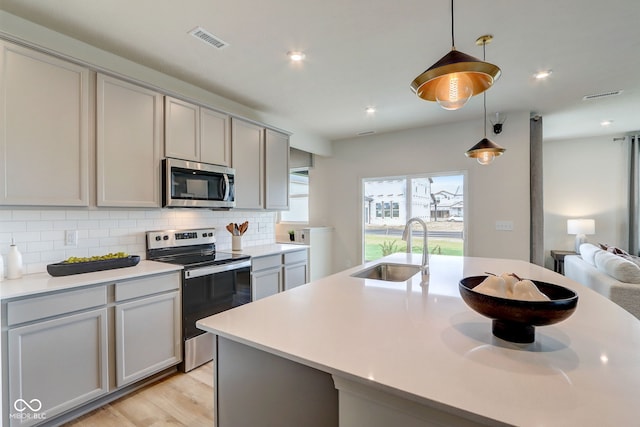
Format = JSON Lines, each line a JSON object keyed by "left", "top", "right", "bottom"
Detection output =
{"left": 147, "top": 228, "right": 251, "bottom": 372}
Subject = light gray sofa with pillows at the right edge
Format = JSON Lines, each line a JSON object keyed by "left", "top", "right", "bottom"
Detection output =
{"left": 564, "top": 244, "right": 640, "bottom": 319}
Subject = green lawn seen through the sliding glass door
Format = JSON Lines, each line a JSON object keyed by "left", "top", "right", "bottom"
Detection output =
{"left": 364, "top": 234, "right": 463, "bottom": 261}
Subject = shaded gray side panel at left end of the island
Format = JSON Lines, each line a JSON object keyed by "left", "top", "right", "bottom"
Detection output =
{"left": 214, "top": 336, "right": 338, "bottom": 427}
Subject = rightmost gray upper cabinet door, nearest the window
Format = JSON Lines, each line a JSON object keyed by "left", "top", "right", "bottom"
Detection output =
{"left": 264, "top": 129, "right": 289, "bottom": 210}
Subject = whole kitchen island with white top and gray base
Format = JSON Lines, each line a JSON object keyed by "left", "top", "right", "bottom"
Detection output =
{"left": 198, "top": 254, "right": 640, "bottom": 427}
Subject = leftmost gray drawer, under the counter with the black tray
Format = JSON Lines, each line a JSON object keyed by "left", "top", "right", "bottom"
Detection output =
{"left": 7, "top": 286, "right": 107, "bottom": 326}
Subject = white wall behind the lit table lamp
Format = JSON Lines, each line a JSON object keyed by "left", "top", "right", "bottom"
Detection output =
{"left": 543, "top": 135, "right": 629, "bottom": 268}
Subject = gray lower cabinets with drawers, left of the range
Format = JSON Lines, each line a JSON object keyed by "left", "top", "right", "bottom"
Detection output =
{"left": 0, "top": 272, "right": 182, "bottom": 427}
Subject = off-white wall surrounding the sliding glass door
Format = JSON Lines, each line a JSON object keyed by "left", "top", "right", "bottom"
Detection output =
{"left": 310, "top": 110, "right": 530, "bottom": 271}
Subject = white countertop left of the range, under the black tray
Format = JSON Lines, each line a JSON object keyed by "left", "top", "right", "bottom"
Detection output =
{"left": 0, "top": 260, "right": 182, "bottom": 300}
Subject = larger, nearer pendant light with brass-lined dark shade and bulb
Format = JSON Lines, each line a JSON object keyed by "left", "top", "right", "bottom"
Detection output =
{"left": 411, "top": 0, "right": 500, "bottom": 110}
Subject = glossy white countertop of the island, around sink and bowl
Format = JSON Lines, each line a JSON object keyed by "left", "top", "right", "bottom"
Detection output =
{"left": 198, "top": 254, "right": 640, "bottom": 426}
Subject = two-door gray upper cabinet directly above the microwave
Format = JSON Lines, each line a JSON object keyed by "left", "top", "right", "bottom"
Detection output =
{"left": 165, "top": 96, "right": 231, "bottom": 166}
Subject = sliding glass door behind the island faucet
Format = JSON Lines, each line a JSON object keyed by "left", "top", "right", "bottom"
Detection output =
{"left": 362, "top": 172, "right": 464, "bottom": 261}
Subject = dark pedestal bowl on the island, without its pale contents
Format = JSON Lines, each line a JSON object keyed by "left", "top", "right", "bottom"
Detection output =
{"left": 458, "top": 276, "right": 578, "bottom": 343}
